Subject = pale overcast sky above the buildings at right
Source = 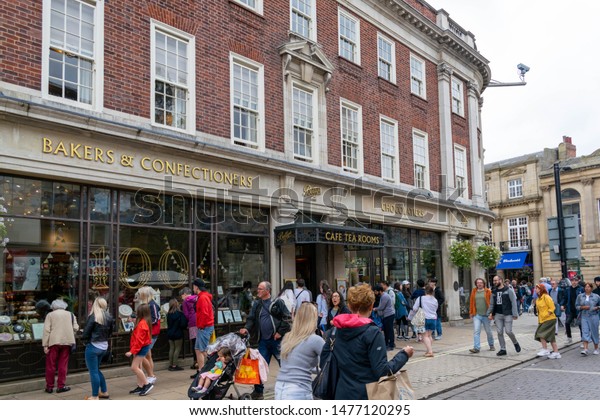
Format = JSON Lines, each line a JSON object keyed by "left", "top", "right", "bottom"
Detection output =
{"left": 427, "top": 0, "right": 600, "bottom": 163}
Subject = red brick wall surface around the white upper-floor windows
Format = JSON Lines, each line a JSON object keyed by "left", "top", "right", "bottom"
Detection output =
{"left": 0, "top": 0, "right": 469, "bottom": 191}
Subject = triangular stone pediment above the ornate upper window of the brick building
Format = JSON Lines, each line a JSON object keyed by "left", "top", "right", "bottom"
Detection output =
{"left": 279, "top": 34, "right": 334, "bottom": 90}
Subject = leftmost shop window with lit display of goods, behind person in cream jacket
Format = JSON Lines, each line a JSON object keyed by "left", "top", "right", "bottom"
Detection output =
{"left": 0, "top": 217, "right": 80, "bottom": 341}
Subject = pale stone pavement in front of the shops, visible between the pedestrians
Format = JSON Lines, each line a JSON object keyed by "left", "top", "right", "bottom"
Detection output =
{"left": 0, "top": 314, "right": 580, "bottom": 400}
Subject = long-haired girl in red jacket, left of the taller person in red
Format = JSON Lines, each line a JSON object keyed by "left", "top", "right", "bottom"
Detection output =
{"left": 125, "top": 303, "right": 154, "bottom": 397}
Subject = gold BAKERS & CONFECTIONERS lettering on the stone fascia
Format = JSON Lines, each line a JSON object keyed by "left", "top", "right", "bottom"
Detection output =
{"left": 42, "top": 137, "right": 254, "bottom": 188}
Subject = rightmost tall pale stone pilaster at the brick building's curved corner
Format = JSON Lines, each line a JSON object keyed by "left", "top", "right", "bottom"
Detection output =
{"left": 467, "top": 81, "right": 485, "bottom": 207}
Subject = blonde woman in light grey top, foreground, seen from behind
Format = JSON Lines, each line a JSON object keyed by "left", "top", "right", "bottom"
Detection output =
{"left": 275, "top": 302, "right": 325, "bottom": 400}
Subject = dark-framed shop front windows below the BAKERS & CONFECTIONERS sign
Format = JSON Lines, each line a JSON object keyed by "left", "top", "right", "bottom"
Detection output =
{"left": 0, "top": 175, "right": 269, "bottom": 380}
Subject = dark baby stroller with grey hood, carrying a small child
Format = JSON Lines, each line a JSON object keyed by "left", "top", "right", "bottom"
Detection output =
{"left": 188, "top": 333, "right": 251, "bottom": 400}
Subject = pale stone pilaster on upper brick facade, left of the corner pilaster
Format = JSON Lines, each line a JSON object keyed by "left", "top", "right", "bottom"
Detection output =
{"left": 437, "top": 63, "right": 455, "bottom": 198}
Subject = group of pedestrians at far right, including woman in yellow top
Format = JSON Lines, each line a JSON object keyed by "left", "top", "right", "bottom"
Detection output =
{"left": 469, "top": 276, "right": 600, "bottom": 359}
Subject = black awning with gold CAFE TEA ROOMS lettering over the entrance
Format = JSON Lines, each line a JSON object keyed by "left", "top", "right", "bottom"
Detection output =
{"left": 275, "top": 223, "right": 385, "bottom": 248}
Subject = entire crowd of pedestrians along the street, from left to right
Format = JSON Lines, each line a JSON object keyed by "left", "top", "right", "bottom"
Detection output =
{"left": 42, "top": 276, "right": 600, "bottom": 400}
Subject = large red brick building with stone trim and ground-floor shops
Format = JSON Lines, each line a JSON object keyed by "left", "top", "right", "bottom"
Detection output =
{"left": 0, "top": 0, "right": 493, "bottom": 375}
